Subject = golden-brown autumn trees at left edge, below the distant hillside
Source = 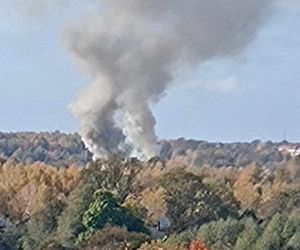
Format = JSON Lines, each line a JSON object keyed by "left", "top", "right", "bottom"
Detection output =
{"left": 0, "top": 164, "right": 81, "bottom": 220}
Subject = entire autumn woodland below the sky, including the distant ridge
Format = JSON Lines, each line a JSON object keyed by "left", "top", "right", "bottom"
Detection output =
{"left": 0, "top": 132, "right": 300, "bottom": 250}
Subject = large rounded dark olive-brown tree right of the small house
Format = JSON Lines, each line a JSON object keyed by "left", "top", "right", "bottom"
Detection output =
{"left": 161, "top": 169, "right": 236, "bottom": 232}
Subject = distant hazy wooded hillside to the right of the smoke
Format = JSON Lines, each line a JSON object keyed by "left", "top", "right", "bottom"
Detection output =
{"left": 161, "top": 138, "right": 294, "bottom": 168}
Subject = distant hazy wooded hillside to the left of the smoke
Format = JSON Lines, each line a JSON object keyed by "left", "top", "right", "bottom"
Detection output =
{"left": 0, "top": 131, "right": 92, "bottom": 166}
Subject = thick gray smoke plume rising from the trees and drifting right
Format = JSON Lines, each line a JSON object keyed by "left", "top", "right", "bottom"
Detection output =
{"left": 65, "top": 0, "right": 272, "bottom": 158}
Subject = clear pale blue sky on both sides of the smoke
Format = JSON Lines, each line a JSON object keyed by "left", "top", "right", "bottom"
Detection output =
{"left": 0, "top": 0, "right": 300, "bottom": 142}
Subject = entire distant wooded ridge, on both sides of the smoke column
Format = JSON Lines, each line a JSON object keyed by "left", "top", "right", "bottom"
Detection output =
{"left": 0, "top": 131, "right": 293, "bottom": 168}
